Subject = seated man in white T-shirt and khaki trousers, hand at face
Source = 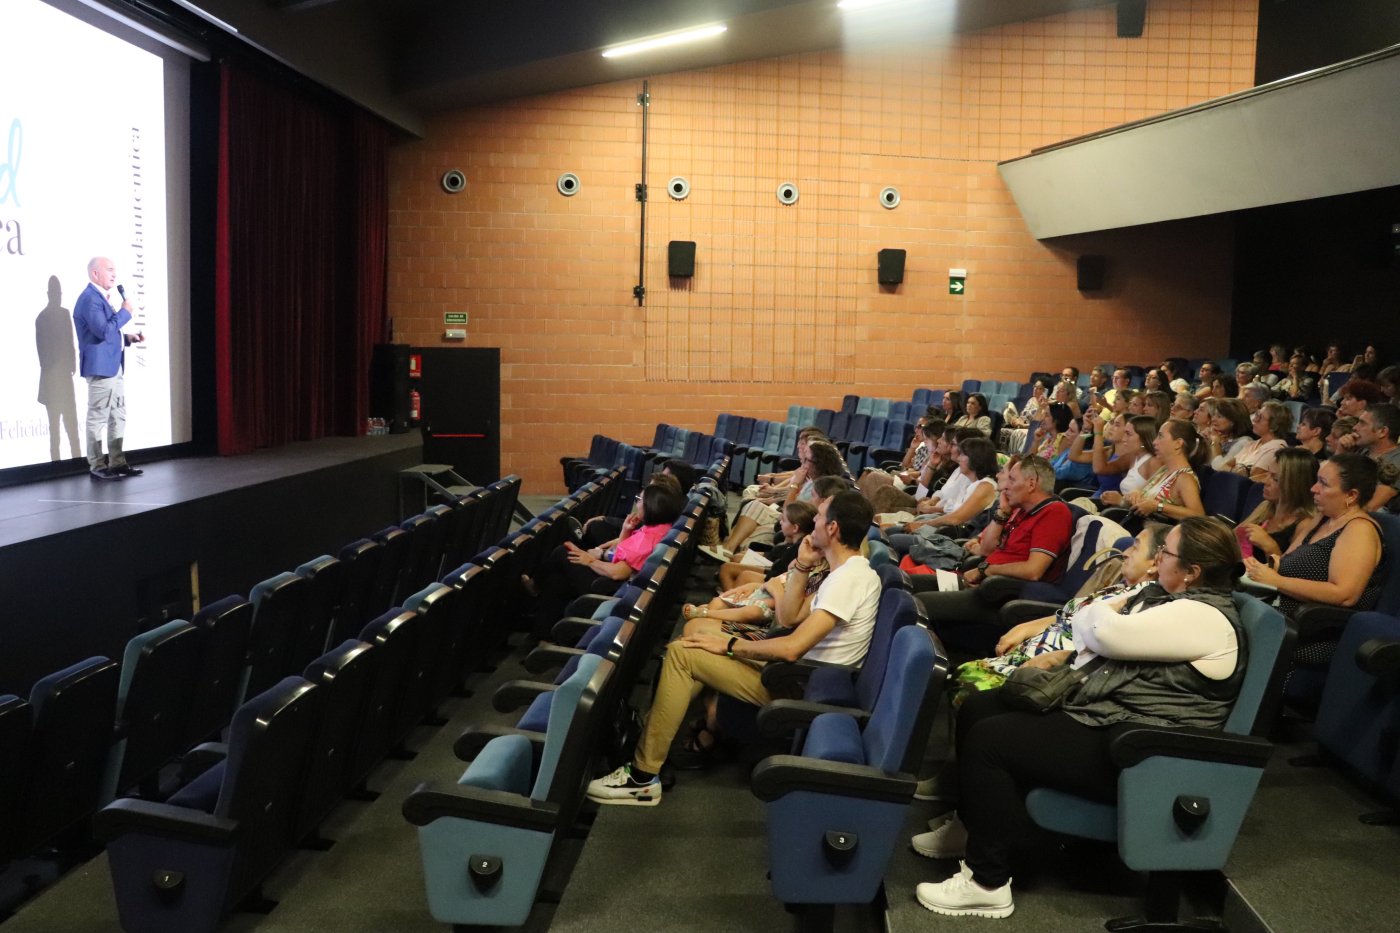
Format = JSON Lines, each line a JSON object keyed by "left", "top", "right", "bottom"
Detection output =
{"left": 588, "top": 490, "right": 881, "bottom": 807}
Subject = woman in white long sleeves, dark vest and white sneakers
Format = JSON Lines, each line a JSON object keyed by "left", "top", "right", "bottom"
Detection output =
{"left": 914, "top": 518, "right": 1245, "bottom": 918}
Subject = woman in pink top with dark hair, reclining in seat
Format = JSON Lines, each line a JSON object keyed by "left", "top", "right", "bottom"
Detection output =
{"left": 521, "top": 483, "right": 685, "bottom": 633}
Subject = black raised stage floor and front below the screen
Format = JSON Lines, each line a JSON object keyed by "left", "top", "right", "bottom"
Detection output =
{"left": 0, "top": 431, "right": 425, "bottom": 695}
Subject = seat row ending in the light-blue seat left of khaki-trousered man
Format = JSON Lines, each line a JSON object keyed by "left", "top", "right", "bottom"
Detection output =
{"left": 403, "top": 458, "right": 728, "bottom": 926}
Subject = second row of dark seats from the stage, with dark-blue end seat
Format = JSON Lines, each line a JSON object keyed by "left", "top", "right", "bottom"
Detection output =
{"left": 78, "top": 471, "right": 641, "bottom": 933}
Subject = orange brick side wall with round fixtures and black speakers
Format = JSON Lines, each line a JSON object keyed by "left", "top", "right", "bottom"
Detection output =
{"left": 389, "top": 0, "right": 1257, "bottom": 493}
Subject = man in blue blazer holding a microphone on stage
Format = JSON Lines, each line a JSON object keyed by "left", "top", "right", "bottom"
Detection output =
{"left": 73, "top": 256, "right": 143, "bottom": 479}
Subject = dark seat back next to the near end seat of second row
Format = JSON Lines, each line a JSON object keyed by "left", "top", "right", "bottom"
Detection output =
{"left": 293, "top": 639, "right": 378, "bottom": 849}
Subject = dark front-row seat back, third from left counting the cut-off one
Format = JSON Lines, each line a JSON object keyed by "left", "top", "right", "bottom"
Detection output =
{"left": 99, "top": 619, "right": 204, "bottom": 803}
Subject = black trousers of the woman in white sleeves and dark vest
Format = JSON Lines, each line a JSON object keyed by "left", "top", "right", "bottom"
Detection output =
{"left": 956, "top": 689, "right": 1133, "bottom": 888}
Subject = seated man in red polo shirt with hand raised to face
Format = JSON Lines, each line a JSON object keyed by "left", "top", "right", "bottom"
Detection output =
{"left": 917, "top": 457, "right": 1074, "bottom": 657}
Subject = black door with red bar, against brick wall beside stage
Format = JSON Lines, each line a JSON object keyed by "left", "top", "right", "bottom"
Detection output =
{"left": 410, "top": 347, "right": 501, "bottom": 486}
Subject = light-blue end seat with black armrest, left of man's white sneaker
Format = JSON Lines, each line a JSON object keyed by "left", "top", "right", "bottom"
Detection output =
{"left": 403, "top": 656, "right": 613, "bottom": 926}
